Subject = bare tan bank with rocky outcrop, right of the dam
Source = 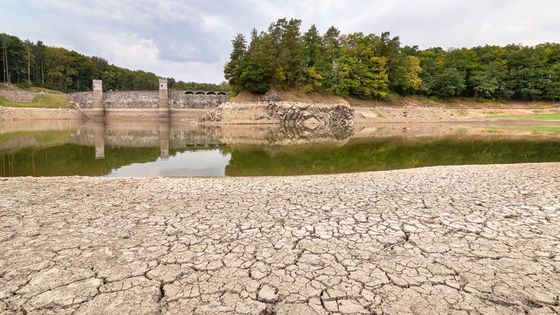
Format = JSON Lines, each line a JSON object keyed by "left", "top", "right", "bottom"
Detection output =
{"left": 200, "top": 101, "right": 560, "bottom": 128}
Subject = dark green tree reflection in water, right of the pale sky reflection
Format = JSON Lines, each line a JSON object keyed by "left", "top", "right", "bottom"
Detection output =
{"left": 224, "top": 138, "right": 560, "bottom": 176}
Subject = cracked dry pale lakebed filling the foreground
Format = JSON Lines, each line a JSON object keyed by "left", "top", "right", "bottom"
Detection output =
{"left": 0, "top": 163, "right": 560, "bottom": 314}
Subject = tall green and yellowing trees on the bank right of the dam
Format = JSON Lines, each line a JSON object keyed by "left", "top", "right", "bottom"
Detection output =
{"left": 224, "top": 18, "right": 560, "bottom": 101}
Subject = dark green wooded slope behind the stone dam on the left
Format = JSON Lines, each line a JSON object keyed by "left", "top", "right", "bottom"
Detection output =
{"left": 0, "top": 33, "right": 228, "bottom": 92}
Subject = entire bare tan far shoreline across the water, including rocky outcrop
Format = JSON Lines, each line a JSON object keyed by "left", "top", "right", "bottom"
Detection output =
{"left": 0, "top": 102, "right": 560, "bottom": 129}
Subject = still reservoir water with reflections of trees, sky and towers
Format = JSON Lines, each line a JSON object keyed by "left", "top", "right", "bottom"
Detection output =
{"left": 0, "top": 121, "right": 560, "bottom": 177}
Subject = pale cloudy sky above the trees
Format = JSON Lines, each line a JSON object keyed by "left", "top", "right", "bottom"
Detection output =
{"left": 0, "top": 0, "right": 560, "bottom": 83}
